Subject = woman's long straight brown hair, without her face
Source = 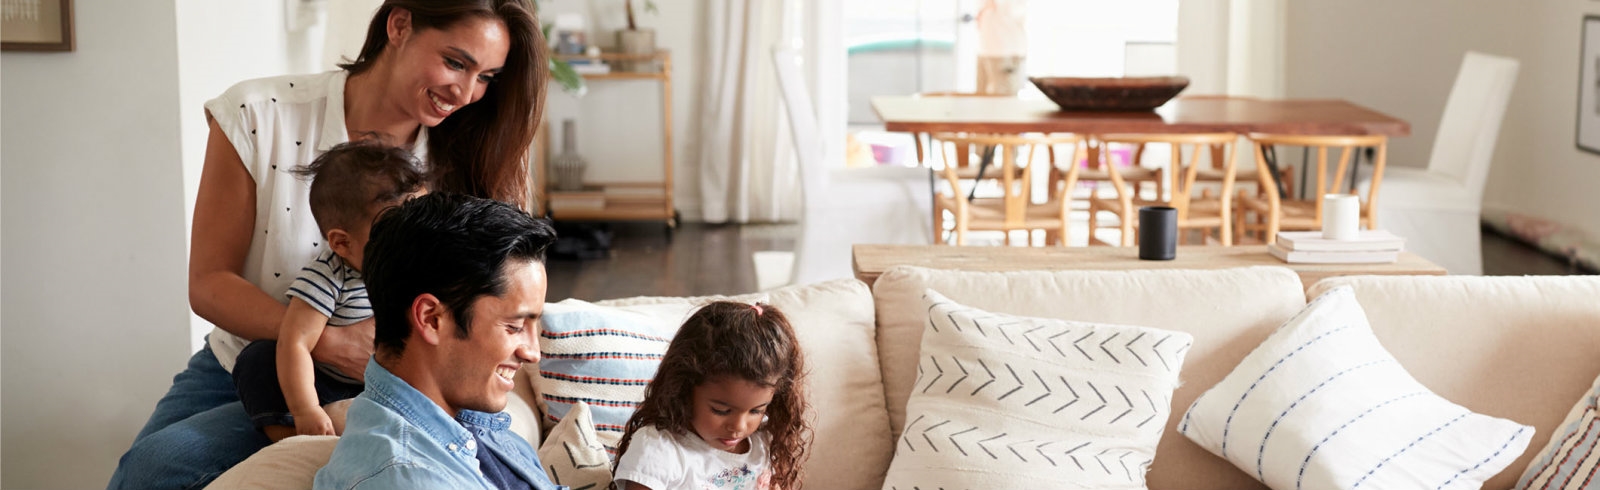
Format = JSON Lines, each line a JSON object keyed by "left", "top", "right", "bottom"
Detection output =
{"left": 339, "top": 0, "right": 550, "bottom": 208}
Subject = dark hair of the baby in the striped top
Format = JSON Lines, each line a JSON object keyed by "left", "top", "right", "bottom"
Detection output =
{"left": 291, "top": 141, "right": 427, "bottom": 235}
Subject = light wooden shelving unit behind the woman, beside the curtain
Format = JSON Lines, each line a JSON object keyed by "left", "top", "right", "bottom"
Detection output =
{"left": 533, "top": 50, "right": 677, "bottom": 227}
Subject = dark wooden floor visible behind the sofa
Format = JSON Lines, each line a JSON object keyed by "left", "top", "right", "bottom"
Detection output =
{"left": 547, "top": 223, "right": 1590, "bottom": 301}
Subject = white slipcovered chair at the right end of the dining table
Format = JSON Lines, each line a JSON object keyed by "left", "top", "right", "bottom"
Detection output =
{"left": 1362, "top": 51, "right": 1518, "bottom": 275}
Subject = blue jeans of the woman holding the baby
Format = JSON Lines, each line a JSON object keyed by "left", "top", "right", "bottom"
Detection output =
{"left": 107, "top": 346, "right": 272, "bottom": 490}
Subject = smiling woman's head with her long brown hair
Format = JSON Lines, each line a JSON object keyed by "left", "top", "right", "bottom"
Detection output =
{"left": 341, "top": 0, "right": 549, "bottom": 205}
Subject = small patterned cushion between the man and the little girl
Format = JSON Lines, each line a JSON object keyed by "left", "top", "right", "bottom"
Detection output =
{"left": 539, "top": 402, "right": 611, "bottom": 490}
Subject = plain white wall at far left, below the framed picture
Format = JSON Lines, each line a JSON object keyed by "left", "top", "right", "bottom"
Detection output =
{"left": 0, "top": 0, "right": 189, "bottom": 488}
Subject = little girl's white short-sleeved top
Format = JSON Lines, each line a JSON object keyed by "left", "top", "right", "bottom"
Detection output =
{"left": 613, "top": 428, "right": 771, "bottom": 490}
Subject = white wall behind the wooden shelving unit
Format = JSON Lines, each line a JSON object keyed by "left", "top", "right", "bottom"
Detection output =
{"left": 539, "top": 0, "right": 706, "bottom": 221}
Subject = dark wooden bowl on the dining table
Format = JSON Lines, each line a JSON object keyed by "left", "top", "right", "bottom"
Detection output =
{"left": 1027, "top": 77, "right": 1189, "bottom": 110}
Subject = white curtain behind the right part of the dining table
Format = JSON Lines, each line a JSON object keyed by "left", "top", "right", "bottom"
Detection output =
{"left": 1178, "top": 0, "right": 1288, "bottom": 99}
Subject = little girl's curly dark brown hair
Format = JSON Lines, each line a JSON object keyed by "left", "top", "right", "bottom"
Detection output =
{"left": 618, "top": 301, "right": 811, "bottom": 488}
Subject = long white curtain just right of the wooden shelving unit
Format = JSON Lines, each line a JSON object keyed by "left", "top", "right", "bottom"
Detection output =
{"left": 699, "top": 0, "right": 800, "bottom": 223}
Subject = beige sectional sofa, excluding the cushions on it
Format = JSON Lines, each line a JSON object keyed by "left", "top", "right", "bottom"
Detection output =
{"left": 213, "top": 267, "right": 1600, "bottom": 490}
